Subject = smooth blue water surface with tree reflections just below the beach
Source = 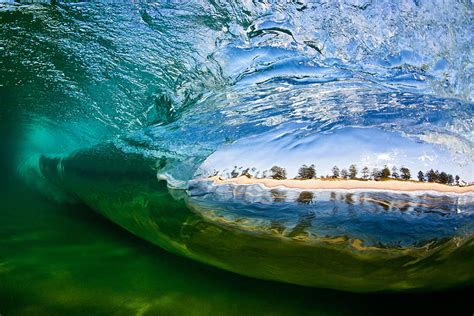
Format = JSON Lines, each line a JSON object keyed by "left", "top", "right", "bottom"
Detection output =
{"left": 188, "top": 181, "right": 474, "bottom": 247}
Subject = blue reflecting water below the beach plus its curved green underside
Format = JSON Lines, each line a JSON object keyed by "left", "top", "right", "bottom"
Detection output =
{"left": 17, "top": 144, "right": 473, "bottom": 292}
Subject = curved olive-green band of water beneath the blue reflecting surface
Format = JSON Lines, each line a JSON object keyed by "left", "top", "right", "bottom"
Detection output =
{"left": 32, "top": 149, "right": 473, "bottom": 292}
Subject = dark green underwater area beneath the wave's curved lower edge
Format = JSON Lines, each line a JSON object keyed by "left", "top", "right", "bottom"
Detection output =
{"left": 0, "top": 181, "right": 472, "bottom": 315}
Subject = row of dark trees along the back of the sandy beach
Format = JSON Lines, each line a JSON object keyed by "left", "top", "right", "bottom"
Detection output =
{"left": 224, "top": 164, "right": 461, "bottom": 185}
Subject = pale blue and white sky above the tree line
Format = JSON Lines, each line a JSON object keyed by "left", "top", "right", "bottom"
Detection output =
{"left": 201, "top": 123, "right": 474, "bottom": 181}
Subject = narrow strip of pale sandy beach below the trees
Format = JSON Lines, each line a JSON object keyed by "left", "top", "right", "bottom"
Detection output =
{"left": 209, "top": 176, "right": 474, "bottom": 193}
